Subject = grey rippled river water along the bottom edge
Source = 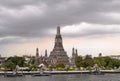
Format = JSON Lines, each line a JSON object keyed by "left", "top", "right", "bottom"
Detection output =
{"left": 0, "top": 74, "right": 120, "bottom": 81}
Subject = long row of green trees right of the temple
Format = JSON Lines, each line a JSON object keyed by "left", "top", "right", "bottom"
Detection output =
{"left": 75, "top": 56, "right": 120, "bottom": 69}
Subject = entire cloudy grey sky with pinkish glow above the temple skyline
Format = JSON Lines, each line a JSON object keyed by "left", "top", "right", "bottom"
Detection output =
{"left": 0, "top": 0, "right": 120, "bottom": 56}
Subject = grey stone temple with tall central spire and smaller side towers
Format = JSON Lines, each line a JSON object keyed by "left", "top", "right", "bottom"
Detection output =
{"left": 35, "top": 26, "right": 77, "bottom": 66}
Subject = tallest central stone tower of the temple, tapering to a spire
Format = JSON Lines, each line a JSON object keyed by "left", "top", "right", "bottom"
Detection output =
{"left": 49, "top": 26, "right": 69, "bottom": 65}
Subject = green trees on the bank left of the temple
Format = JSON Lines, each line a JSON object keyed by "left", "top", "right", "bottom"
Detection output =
{"left": 2, "top": 56, "right": 35, "bottom": 70}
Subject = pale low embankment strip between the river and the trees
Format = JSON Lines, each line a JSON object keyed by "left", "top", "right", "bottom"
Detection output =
{"left": 0, "top": 70, "right": 120, "bottom": 75}
